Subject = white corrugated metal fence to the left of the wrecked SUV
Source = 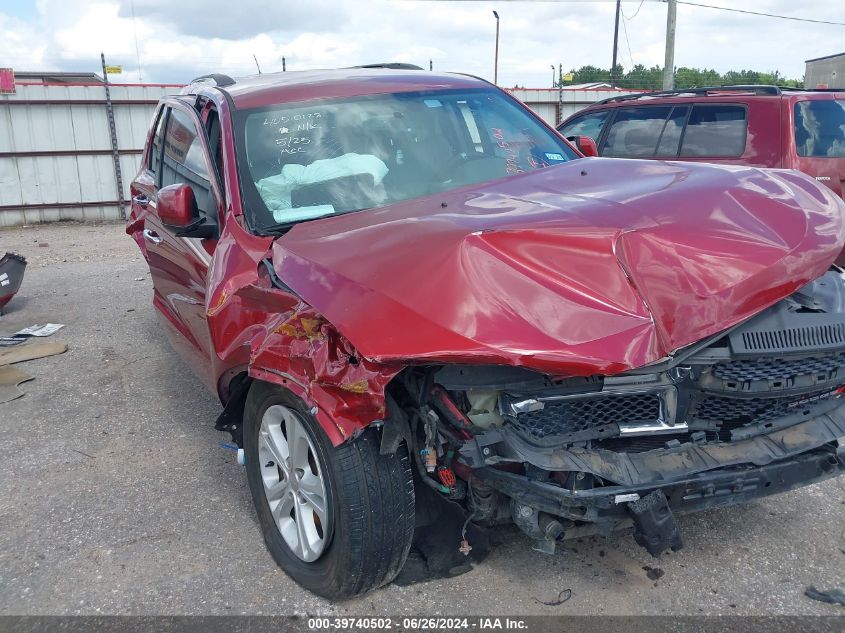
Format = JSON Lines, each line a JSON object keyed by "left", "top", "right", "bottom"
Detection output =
{"left": 0, "top": 84, "right": 179, "bottom": 226}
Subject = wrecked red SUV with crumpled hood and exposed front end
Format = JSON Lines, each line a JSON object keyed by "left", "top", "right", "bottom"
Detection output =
{"left": 127, "top": 65, "right": 845, "bottom": 598}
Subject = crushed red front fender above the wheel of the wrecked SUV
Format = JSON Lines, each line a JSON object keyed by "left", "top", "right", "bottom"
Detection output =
{"left": 206, "top": 223, "right": 404, "bottom": 445}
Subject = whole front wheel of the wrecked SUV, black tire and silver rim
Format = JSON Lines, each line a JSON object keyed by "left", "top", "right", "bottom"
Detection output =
{"left": 243, "top": 382, "right": 414, "bottom": 599}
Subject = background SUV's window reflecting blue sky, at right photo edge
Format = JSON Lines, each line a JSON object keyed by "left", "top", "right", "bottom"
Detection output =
{"left": 795, "top": 99, "right": 845, "bottom": 158}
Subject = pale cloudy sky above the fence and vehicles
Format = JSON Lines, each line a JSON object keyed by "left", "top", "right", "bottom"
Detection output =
{"left": 0, "top": 0, "right": 845, "bottom": 87}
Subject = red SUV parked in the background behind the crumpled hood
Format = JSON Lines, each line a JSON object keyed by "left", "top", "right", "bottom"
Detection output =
{"left": 558, "top": 86, "right": 845, "bottom": 196}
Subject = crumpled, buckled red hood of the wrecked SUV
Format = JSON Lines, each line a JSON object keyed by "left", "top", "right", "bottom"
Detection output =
{"left": 273, "top": 159, "right": 845, "bottom": 375}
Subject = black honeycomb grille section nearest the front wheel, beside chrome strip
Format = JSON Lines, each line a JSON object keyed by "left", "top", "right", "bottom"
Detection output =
{"left": 515, "top": 394, "right": 660, "bottom": 439}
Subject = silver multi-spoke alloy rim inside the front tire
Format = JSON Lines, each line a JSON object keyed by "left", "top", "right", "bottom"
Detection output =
{"left": 258, "top": 404, "right": 332, "bottom": 563}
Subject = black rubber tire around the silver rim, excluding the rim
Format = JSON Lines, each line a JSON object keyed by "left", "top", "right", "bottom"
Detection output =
{"left": 243, "top": 381, "right": 415, "bottom": 600}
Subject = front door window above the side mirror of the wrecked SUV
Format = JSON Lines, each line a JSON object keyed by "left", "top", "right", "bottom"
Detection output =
{"left": 161, "top": 109, "right": 214, "bottom": 215}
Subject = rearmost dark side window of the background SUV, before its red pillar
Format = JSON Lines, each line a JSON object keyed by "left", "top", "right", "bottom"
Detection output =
{"left": 681, "top": 105, "right": 747, "bottom": 158}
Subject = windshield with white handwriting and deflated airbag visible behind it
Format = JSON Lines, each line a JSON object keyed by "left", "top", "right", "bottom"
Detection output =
{"left": 237, "top": 89, "right": 577, "bottom": 232}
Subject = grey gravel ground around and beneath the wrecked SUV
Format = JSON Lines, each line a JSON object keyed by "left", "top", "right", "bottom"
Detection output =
{"left": 0, "top": 224, "right": 845, "bottom": 615}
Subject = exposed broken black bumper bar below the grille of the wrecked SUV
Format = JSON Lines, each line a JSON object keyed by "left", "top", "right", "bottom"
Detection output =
{"left": 461, "top": 407, "right": 845, "bottom": 556}
